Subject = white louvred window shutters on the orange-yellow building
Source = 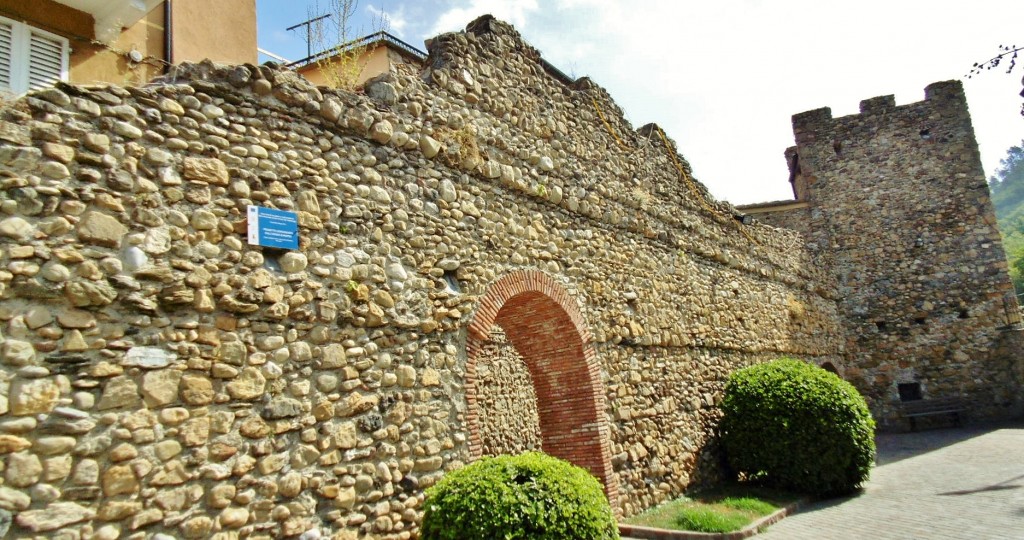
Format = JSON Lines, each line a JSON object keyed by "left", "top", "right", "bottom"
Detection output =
{"left": 0, "top": 16, "right": 71, "bottom": 94}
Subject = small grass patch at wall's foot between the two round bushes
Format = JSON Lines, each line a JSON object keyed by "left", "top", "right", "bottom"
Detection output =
{"left": 626, "top": 484, "right": 800, "bottom": 533}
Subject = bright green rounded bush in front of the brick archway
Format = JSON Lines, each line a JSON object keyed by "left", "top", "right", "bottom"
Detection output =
{"left": 421, "top": 452, "right": 618, "bottom": 540}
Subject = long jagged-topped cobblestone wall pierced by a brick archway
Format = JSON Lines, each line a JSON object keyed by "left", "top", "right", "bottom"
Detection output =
{"left": 0, "top": 17, "right": 844, "bottom": 539}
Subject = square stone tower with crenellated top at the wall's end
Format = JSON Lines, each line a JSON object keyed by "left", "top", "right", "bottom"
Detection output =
{"left": 743, "top": 81, "right": 1021, "bottom": 422}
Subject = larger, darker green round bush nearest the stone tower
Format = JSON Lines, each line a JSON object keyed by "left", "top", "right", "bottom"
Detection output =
{"left": 721, "top": 359, "right": 874, "bottom": 497}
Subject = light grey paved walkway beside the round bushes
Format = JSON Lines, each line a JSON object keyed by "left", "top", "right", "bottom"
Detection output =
{"left": 755, "top": 422, "right": 1024, "bottom": 540}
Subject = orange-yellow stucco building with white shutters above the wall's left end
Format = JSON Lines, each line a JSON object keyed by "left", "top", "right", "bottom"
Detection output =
{"left": 0, "top": 0, "right": 257, "bottom": 94}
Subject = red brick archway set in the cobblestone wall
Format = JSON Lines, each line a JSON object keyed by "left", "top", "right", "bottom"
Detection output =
{"left": 466, "top": 271, "right": 618, "bottom": 508}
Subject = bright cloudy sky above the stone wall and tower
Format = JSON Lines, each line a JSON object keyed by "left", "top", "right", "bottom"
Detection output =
{"left": 256, "top": 0, "right": 1024, "bottom": 205}
